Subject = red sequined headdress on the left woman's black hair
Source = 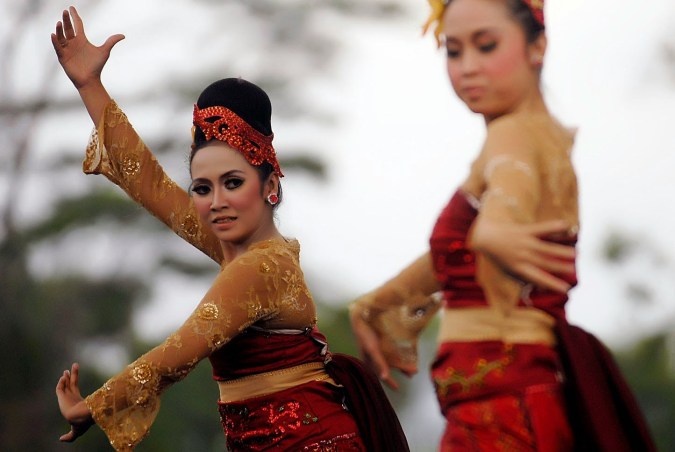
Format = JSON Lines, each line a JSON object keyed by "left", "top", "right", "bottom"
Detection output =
{"left": 192, "top": 104, "right": 284, "bottom": 177}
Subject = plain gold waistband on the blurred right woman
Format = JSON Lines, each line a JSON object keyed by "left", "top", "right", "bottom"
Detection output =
{"left": 438, "top": 307, "right": 556, "bottom": 346}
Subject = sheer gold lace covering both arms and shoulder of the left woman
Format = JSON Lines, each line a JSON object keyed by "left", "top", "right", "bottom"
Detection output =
{"left": 83, "top": 101, "right": 316, "bottom": 450}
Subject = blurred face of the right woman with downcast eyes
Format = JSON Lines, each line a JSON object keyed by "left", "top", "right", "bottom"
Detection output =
{"left": 443, "top": 0, "right": 543, "bottom": 119}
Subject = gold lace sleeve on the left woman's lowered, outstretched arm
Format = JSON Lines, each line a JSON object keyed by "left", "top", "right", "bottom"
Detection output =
{"left": 85, "top": 242, "right": 302, "bottom": 450}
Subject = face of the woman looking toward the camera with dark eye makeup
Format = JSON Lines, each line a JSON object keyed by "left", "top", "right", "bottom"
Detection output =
{"left": 190, "top": 140, "right": 278, "bottom": 249}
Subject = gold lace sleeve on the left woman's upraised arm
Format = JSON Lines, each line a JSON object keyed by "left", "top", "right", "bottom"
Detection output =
{"left": 82, "top": 100, "right": 223, "bottom": 264}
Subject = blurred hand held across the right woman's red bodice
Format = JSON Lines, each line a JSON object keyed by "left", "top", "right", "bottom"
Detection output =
{"left": 471, "top": 219, "right": 576, "bottom": 293}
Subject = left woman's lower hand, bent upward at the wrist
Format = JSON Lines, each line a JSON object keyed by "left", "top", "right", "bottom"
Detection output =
{"left": 56, "top": 363, "right": 94, "bottom": 442}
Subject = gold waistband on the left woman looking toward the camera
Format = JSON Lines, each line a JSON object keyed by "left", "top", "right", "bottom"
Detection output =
{"left": 218, "top": 362, "right": 336, "bottom": 403}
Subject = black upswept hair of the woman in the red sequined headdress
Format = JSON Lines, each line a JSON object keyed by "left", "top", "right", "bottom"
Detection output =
{"left": 189, "top": 78, "right": 282, "bottom": 208}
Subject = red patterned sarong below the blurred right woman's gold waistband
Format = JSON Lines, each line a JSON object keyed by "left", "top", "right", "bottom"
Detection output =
{"left": 432, "top": 341, "right": 573, "bottom": 452}
